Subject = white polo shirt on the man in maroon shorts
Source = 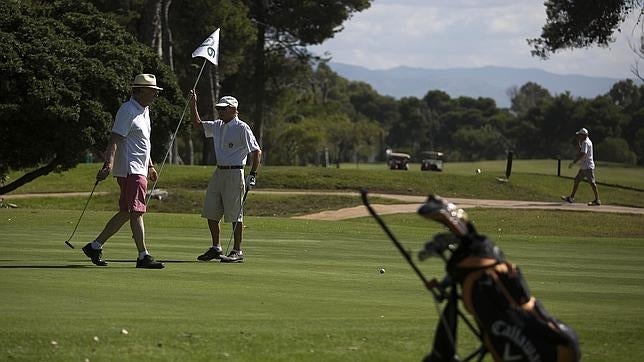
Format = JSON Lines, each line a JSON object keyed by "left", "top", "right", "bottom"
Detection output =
{"left": 112, "top": 98, "right": 151, "bottom": 177}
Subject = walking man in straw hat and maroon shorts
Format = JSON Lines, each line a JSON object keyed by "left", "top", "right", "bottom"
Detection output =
{"left": 83, "top": 74, "right": 164, "bottom": 269}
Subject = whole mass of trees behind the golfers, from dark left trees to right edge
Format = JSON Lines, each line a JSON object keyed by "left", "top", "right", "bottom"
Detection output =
{"left": 0, "top": 0, "right": 644, "bottom": 194}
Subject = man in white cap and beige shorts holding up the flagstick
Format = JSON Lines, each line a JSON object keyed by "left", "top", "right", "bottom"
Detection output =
{"left": 190, "top": 89, "right": 262, "bottom": 263}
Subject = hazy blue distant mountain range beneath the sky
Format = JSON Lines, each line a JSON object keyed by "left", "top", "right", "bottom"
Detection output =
{"left": 329, "top": 62, "right": 620, "bottom": 107}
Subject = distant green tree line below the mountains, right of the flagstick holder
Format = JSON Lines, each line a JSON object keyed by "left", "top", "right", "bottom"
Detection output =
{"left": 262, "top": 68, "right": 644, "bottom": 165}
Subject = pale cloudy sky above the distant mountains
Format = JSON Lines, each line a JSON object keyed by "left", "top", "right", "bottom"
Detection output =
{"left": 309, "top": 0, "right": 644, "bottom": 79}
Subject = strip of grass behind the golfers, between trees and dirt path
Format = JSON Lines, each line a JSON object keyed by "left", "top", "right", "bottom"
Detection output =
{"left": 9, "top": 160, "right": 644, "bottom": 212}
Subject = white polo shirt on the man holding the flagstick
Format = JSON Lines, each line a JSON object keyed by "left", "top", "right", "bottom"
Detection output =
{"left": 202, "top": 117, "right": 260, "bottom": 166}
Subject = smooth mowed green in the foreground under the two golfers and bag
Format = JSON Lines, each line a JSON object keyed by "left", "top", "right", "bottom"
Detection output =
{"left": 0, "top": 205, "right": 644, "bottom": 361}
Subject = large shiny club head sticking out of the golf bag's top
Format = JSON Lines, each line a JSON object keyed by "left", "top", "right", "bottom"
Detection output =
{"left": 418, "top": 195, "right": 469, "bottom": 236}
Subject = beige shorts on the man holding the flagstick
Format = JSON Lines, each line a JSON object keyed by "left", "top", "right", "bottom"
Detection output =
{"left": 201, "top": 168, "right": 245, "bottom": 222}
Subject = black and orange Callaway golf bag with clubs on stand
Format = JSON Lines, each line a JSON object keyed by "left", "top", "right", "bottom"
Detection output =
{"left": 362, "top": 191, "right": 581, "bottom": 362}
